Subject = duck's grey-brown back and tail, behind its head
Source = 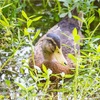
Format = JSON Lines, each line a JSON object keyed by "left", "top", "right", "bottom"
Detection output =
{"left": 36, "top": 9, "right": 84, "bottom": 67}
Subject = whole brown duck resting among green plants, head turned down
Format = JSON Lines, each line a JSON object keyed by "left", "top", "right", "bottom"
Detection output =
{"left": 29, "top": 9, "right": 84, "bottom": 80}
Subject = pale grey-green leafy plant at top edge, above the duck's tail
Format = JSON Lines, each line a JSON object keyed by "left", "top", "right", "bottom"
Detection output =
{"left": 59, "top": 0, "right": 96, "bottom": 18}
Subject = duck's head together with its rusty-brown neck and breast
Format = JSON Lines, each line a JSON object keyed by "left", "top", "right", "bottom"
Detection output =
{"left": 29, "top": 33, "right": 71, "bottom": 74}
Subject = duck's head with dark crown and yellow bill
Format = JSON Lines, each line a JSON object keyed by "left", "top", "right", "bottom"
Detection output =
{"left": 42, "top": 33, "right": 67, "bottom": 65}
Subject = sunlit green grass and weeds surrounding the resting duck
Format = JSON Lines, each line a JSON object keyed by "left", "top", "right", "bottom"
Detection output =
{"left": 0, "top": 0, "right": 100, "bottom": 100}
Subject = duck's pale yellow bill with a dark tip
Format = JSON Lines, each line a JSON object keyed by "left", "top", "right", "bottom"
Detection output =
{"left": 54, "top": 47, "right": 67, "bottom": 65}
